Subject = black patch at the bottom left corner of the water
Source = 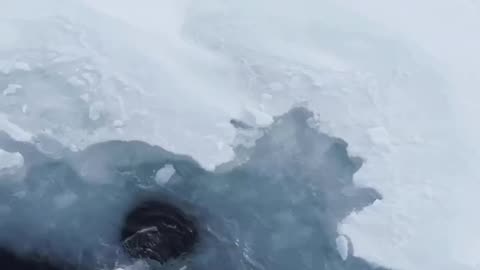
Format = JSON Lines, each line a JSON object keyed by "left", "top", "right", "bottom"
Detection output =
{"left": 0, "top": 248, "right": 66, "bottom": 270}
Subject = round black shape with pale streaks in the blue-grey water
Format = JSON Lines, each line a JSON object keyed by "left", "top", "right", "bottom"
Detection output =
{"left": 121, "top": 201, "right": 198, "bottom": 263}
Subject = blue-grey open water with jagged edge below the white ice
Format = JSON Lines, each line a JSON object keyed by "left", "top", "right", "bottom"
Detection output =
{"left": 0, "top": 108, "right": 384, "bottom": 270}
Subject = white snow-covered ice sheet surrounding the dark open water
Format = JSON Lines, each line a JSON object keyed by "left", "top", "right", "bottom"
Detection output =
{"left": 0, "top": 0, "right": 480, "bottom": 270}
